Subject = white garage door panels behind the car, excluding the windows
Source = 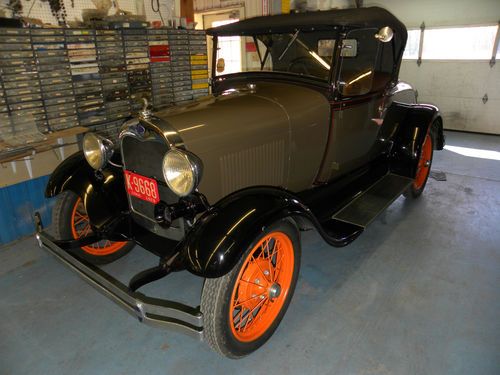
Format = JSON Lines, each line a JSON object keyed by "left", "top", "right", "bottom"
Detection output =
{"left": 365, "top": 0, "right": 500, "bottom": 134}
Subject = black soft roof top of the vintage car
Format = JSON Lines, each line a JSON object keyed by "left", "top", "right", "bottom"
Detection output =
{"left": 207, "top": 7, "right": 407, "bottom": 37}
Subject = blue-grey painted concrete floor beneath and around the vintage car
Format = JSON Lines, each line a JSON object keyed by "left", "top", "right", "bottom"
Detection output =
{"left": 0, "top": 132, "right": 500, "bottom": 375}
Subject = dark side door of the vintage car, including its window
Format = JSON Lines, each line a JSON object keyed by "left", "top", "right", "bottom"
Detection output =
{"left": 317, "top": 28, "right": 391, "bottom": 183}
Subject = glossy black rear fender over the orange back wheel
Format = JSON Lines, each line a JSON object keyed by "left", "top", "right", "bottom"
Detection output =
{"left": 384, "top": 102, "right": 444, "bottom": 178}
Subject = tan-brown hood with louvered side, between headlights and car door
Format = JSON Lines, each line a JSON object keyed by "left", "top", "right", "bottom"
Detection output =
{"left": 155, "top": 82, "right": 330, "bottom": 202}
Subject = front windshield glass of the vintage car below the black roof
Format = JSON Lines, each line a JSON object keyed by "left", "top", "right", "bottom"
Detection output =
{"left": 215, "top": 31, "right": 336, "bottom": 81}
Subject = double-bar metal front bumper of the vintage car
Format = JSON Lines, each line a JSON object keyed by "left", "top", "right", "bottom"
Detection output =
{"left": 35, "top": 220, "right": 203, "bottom": 340}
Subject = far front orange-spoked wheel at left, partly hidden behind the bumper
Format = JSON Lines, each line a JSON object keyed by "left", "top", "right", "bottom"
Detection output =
{"left": 52, "top": 191, "right": 134, "bottom": 264}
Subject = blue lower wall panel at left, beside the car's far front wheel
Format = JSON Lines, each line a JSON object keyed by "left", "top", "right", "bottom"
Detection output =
{"left": 0, "top": 176, "right": 55, "bottom": 244}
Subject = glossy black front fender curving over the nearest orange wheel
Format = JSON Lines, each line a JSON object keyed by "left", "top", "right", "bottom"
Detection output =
{"left": 177, "top": 186, "right": 360, "bottom": 278}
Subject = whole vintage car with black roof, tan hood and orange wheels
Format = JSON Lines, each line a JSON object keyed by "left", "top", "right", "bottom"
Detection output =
{"left": 36, "top": 8, "right": 444, "bottom": 358}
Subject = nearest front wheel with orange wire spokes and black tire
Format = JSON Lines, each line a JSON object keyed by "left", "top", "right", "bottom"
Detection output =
{"left": 201, "top": 221, "right": 301, "bottom": 358}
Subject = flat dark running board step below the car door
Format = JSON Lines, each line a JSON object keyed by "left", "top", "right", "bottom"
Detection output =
{"left": 332, "top": 173, "right": 413, "bottom": 228}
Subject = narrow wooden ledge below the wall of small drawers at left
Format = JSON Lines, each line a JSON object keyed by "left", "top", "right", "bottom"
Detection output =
{"left": 0, "top": 126, "right": 89, "bottom": 163}
